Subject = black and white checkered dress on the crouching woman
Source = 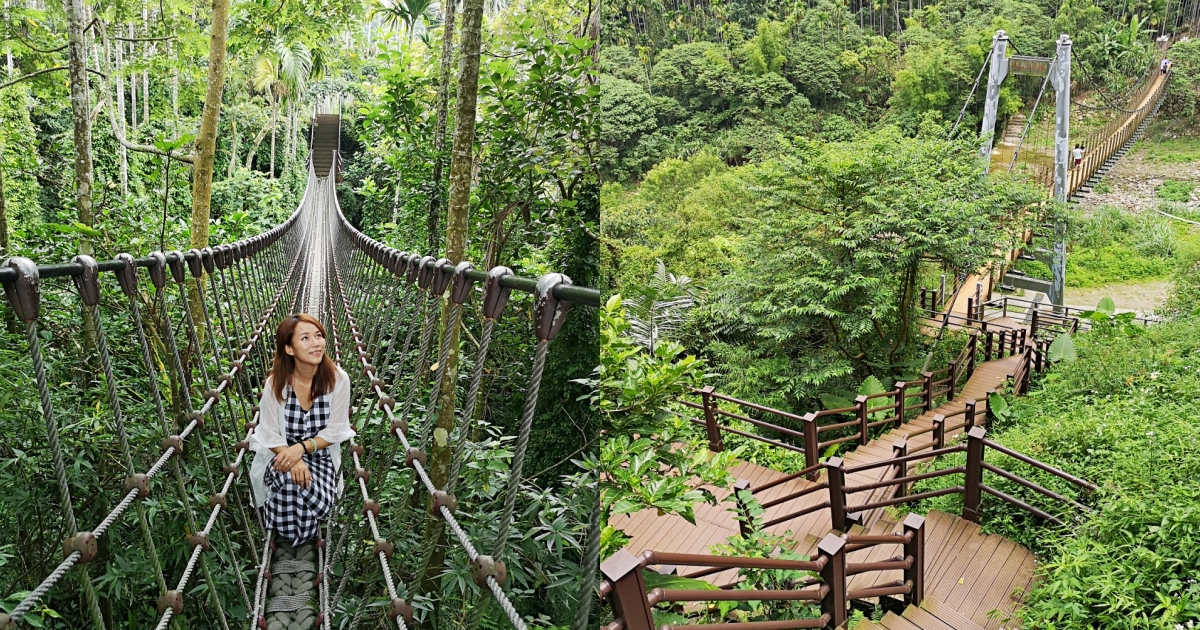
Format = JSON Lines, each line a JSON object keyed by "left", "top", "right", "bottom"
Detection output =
{"left": 263, "top": 385, "right": 337, "bottom": 545}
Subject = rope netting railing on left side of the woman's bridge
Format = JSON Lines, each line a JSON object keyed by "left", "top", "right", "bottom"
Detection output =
{"left": 0, "top": 198, "right": 299, "bottom": 628}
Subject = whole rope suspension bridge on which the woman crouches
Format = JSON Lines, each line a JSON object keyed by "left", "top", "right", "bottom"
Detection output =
{"left": 0, "top": 114, "right": 600, "bottom": 630}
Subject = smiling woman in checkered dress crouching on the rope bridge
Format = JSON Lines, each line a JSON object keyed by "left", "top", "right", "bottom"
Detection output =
{"left": 250, "top": 313, "right": 354, "bottom": 545}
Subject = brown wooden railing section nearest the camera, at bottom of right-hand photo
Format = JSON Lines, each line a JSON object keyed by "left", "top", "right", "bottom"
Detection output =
{"left": 600, "top": 514, "right": 926, "bottom": 630}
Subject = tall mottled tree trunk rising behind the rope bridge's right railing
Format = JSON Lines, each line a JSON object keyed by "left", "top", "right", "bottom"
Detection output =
{"left": 421, "top": 0, "right": 484, "bottom": 600}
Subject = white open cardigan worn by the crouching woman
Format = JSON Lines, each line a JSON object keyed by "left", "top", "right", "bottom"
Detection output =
{"left": 250, "top": 367, "right": 354, "bottom": 508}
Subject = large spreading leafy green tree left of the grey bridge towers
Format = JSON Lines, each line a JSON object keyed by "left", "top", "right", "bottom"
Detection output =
{"left": 701, "top": 128, "right": 1036, "bottom": 410}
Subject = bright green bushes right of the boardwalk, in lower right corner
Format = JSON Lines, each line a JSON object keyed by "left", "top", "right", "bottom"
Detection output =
{"left": 914, "top": 321, "right": 1200, "bottom": 630}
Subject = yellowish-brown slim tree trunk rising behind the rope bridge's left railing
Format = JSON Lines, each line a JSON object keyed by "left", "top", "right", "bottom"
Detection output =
{"left": 188, "top": 0, "right": 229, "bottom": 348}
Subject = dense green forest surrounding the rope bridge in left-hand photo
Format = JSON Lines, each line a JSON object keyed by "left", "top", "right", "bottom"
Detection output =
{"left": 0, "top": 0, "right": 599, "bottom": 628}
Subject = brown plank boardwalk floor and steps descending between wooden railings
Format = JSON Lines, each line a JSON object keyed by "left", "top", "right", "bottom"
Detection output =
{"left": 610, "top": 356, "right": 1034, "bottom": 630}
